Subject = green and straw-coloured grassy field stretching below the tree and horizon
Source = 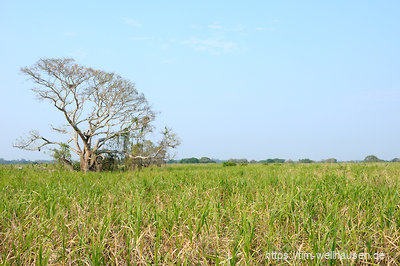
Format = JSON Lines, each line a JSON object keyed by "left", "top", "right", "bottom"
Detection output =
{"left": 0, "top": 163, "right": 400, "bottom": 265}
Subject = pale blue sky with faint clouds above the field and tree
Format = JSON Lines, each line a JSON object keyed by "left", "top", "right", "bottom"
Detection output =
{"left": 0, "top": 0, "right": 400, "bottom": 160}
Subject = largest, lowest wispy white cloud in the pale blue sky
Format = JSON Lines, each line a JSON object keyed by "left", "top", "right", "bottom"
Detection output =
{"left": 182, "top": 37, "right": 238, "bottom": 55}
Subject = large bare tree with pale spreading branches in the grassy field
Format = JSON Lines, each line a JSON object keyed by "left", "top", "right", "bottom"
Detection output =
{"left": 14, "top": 59, "right": 179, "bottom": 172}
